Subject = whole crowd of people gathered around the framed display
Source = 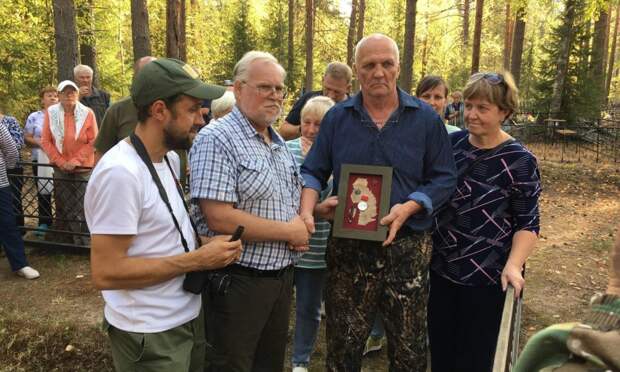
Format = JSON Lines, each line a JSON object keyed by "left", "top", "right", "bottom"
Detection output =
{"left": 0, "top": 34, "right": 616, "bottom": 372}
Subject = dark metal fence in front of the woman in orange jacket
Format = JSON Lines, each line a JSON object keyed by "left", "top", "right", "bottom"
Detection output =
{"left": 9, "top": 163, "right": 90, "bottom": 248}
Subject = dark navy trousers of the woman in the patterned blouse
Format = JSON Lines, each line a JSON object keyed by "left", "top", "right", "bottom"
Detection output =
{"left": 428, "top": 271, "right": 505, "bottom": 372}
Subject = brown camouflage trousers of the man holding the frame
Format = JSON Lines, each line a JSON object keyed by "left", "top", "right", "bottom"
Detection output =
{"left": 325, "top": 232, "right": 432, "bottom": 372}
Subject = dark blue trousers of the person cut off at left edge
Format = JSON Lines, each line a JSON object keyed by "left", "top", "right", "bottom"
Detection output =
{"left": 0, "top": 186, "right": 28, "bottom": 271}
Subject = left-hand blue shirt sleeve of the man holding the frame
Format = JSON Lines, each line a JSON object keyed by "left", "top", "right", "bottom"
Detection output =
{"left": 301, "top": 111, "right": 335, "bottom": 193}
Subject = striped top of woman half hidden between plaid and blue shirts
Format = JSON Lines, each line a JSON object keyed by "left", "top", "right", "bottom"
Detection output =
{"left": 286, "top": 138, "right": 332, "bottom": 269}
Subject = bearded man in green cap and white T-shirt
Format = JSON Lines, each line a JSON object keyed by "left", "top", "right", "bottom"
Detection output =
{"left": 84, "top": 59, "right": 241, "bottom": 372}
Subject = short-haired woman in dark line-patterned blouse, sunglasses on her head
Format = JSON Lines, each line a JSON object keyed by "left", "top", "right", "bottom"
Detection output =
{"left": 428, "top": 73, "right": 541, "bottom": 372}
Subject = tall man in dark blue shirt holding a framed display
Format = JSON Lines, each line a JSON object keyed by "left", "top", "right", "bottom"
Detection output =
{"left": 300, "top": 34, "right": 456, "bottom": 371}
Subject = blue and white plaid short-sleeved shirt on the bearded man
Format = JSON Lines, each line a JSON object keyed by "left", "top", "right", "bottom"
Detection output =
{"left": 190, "top": 106, "right": 302, "bottom": 270}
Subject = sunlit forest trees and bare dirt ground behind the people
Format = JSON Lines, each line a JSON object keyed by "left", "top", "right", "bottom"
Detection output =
{"left": 0, "top": 0, "right": 620, "bottom": 371}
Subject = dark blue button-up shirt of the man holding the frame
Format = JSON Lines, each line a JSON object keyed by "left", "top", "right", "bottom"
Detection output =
{"left": 301, "top": 89, "right": 456, "bottom": 231}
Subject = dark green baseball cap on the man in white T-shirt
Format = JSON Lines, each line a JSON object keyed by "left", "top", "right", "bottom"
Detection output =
{"left": 131, "top": 58, "right": 226, "bottom": 106}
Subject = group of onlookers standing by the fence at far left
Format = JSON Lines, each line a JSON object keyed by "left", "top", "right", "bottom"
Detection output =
{"left": 0, "top": 65, "right": 110, "bottom": 279}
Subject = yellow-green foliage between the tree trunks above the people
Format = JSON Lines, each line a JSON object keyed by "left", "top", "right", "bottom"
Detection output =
{"left": 0, "top": 0, "right": 618, "bottom": 120}
